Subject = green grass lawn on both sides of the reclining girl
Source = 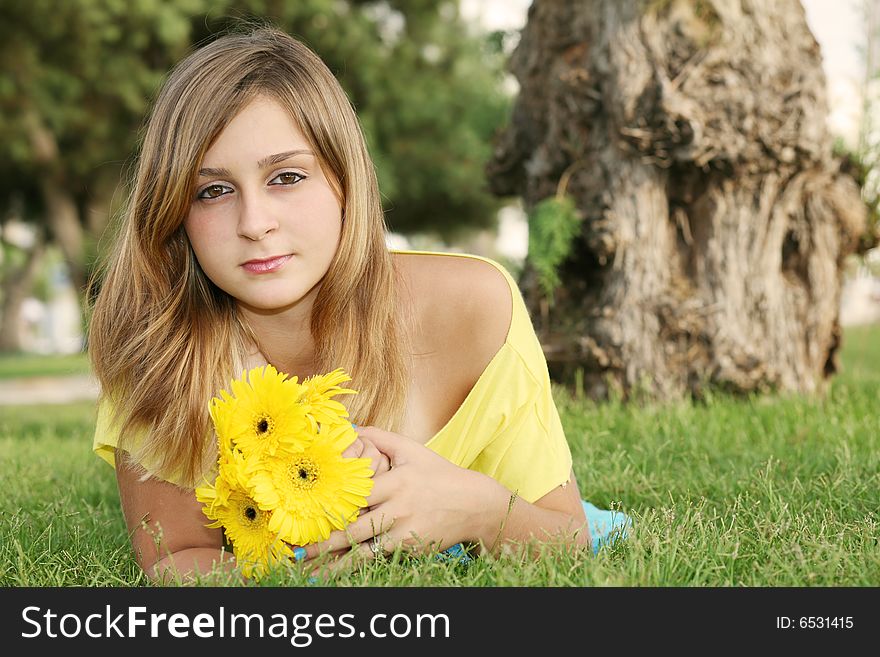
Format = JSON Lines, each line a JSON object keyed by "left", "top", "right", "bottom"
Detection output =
{"left": 0, "top": 327, "right": 880, "bottom": 587}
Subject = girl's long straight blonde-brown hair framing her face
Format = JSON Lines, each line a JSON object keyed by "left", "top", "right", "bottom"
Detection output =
{"left": 89, "top": 27, "right": 408, "bottom": 486}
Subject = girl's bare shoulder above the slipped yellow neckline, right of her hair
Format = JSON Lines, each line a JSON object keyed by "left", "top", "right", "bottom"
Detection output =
{"left": 395, "top": 253, "right": 513, "bottom": 358}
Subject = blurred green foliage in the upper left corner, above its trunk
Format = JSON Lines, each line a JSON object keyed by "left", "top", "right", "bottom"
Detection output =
{"left": 0, "top": 0, "right": 210, "bottom": 179}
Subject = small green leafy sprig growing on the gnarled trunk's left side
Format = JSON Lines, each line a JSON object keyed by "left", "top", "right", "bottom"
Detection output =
{"left": 528, "top": 196, "right": 581, "bottom": 301}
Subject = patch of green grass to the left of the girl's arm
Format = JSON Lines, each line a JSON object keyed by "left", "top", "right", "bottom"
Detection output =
{"left": 0, "top": 403, "right": 143, "bottom": 586}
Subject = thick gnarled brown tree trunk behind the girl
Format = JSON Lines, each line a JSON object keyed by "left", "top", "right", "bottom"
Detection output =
{"left": 489, "top": 0, "right": 865, "bottom": 398}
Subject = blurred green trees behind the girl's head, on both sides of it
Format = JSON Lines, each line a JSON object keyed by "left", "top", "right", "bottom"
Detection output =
{"left": 0, "top": 0, "right": 509, "bottom": 352}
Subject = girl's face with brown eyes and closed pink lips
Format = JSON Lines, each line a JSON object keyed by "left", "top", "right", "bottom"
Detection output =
{"left": 184, "top": 96, "right": 342, "bottom": 313}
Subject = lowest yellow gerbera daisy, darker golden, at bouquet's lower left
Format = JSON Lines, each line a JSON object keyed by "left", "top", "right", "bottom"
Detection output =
{"left": 196, "top": 458, "right": 293, "bottom": 579}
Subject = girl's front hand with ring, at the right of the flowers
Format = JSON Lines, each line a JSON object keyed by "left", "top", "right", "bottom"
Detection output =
{"left": 306, "top": 427, "right": 510, "bottom": 569}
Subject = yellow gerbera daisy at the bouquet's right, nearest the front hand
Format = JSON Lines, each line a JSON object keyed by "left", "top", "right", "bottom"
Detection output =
{"left": 250, "top": 424, "right": 373, "bottom": 545}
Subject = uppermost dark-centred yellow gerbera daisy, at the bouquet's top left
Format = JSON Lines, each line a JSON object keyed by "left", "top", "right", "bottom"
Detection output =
{"left": 210, "top": 365, "right": 311, "bottom": 459}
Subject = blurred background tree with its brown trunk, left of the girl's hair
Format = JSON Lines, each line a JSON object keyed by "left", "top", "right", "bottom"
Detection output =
{"left": 0, "top": 0, "right": 200, "bottom": 349}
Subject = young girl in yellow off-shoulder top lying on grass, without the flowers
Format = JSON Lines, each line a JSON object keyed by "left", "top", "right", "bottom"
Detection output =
{"left": 89, "top": 28, "right": 625, "bottom": 579}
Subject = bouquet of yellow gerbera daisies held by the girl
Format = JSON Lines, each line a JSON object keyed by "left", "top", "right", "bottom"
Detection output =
{"left": 196, "top": 365, "right": 373, "bottom": 579}
